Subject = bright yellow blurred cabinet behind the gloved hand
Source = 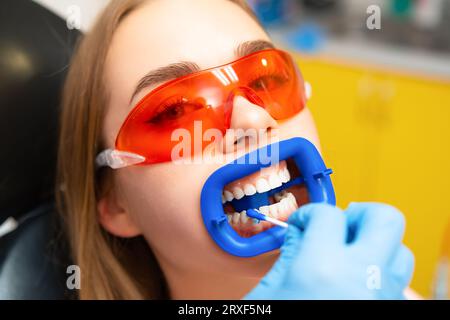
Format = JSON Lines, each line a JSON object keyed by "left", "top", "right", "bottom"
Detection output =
{"left": 298, "top": 57, "right": 450, "bottom": 297}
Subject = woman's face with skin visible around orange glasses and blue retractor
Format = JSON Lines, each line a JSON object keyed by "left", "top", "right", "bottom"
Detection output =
{"left": 99, "top": 0, "right": 318, "bottom": 284}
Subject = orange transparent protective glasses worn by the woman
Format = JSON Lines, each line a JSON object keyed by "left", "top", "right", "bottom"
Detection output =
{"left": 97, "top": 49, "right": 306, "bottom": 168}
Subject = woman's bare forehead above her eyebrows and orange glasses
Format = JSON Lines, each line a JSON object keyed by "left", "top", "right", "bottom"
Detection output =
{"left": 106, "top": 0, "right": 269, "bottom": 107}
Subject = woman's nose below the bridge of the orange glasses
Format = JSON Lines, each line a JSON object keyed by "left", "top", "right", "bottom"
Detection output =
{"left": 223, "top": 95, "right": 278, "bottom": 153}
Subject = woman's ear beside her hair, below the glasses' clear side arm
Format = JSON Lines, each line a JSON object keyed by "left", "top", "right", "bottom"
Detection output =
{"left": 97, "top": 188, "right": 141, "bottom": 238}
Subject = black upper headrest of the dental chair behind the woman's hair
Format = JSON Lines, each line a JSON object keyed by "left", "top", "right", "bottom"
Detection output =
{"left": 0, "top": 0, "right": 80, "bottom": 223}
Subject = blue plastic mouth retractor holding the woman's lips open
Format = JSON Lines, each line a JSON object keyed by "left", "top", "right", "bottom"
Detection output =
{"left": 200, "top": 138, "right": 336, "bottom": 257}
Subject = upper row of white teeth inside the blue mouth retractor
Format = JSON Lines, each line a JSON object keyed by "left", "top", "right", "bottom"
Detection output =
{"left": 222, "top": 168, "right": 291, "bottom": 203}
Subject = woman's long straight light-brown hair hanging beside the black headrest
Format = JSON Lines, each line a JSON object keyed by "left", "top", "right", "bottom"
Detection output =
{"left": 56, "top": 0, "right": 256, "bottom": 299}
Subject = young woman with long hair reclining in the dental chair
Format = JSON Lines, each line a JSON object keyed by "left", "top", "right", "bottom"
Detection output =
{"left": 57, "top": 0, "right": 414, "bottom": 299}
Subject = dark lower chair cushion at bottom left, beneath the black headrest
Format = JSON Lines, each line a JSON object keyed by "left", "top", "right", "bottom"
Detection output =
{"left": 0, "top": 204, "right": 74, "bottom": 300}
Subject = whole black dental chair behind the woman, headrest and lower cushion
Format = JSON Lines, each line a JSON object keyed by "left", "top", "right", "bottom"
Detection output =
{"left": 0, "top": 0, "right": 80, "bottom": 299}
